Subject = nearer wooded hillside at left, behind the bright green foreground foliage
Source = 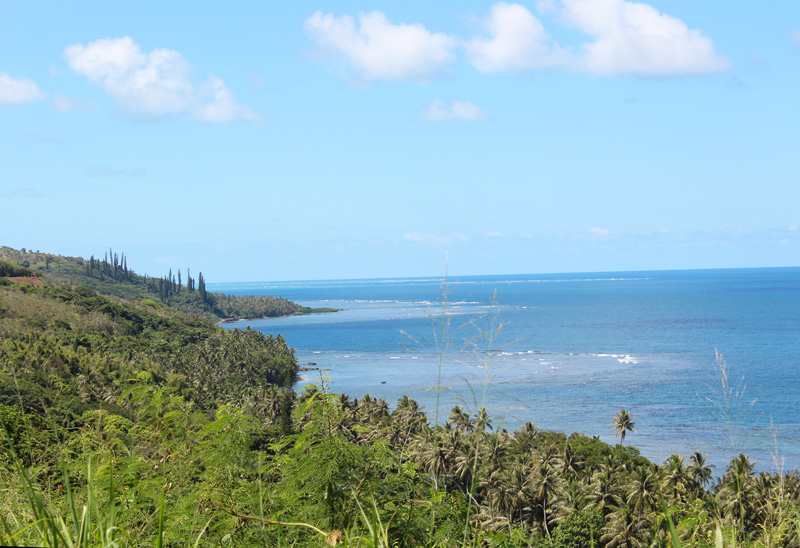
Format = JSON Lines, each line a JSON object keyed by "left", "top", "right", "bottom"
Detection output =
{"left": 0, "top": 278, "right": 297, "bottom": 424}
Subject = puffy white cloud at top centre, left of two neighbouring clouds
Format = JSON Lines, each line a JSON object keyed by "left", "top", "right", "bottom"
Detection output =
{"left": 305, "top": 11, "right": 456, "bottom": 81}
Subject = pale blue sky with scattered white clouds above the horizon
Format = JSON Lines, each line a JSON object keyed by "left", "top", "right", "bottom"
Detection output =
{"left": 0, "top": 0, "right": 800, "bottom": 282}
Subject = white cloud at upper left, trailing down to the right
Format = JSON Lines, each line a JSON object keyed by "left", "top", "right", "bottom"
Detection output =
{"left": 64, "top": 36, "right": 257, "bottom": 122}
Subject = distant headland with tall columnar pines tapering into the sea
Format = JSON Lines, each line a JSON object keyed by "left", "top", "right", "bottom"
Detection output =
{"left": 0, "top": 246, "right": 334, "bottom": 320}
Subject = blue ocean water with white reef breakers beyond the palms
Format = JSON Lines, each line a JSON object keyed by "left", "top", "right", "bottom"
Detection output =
{"left": 209, "top": 268, "right": 800, "bottom": 474}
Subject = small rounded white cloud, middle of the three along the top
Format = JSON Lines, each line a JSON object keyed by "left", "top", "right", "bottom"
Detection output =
{"left": 464, "top": 2, "right": 556, "bottom": 72}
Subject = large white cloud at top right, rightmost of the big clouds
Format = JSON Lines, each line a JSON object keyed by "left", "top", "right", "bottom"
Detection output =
{"left": 561, "top": 0, "right": 728, "bottom": 76}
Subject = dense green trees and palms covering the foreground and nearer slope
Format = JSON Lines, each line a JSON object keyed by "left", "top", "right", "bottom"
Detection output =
{"left": 0, "top": 255, "right": 800, "bottom": 548}
